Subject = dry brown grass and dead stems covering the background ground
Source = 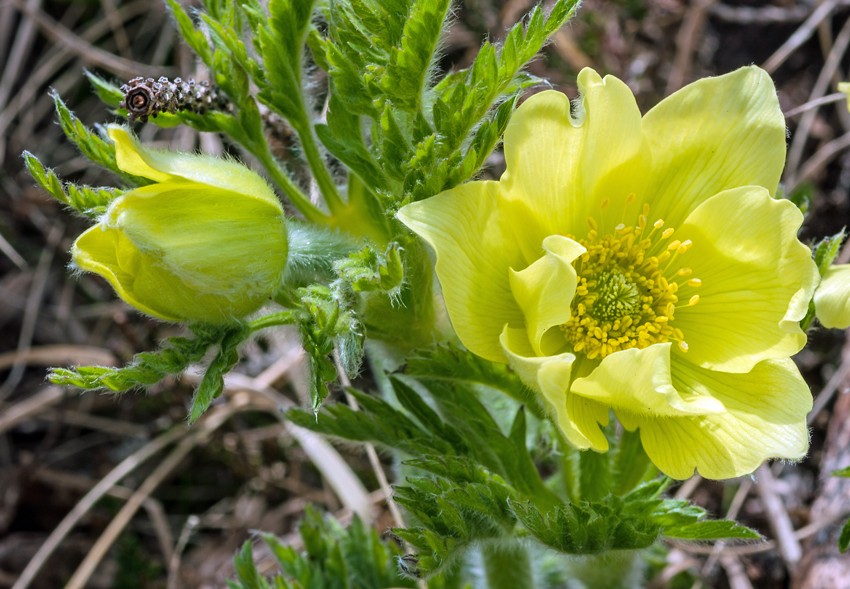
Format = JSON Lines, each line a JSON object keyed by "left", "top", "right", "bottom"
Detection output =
{"left": 0, "top": 0, "right": 850, "bottom": 589}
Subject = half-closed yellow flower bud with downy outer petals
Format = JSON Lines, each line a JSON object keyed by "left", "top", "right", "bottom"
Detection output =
{"left": 71, "top": 126, "right": 287, "bottom": 323}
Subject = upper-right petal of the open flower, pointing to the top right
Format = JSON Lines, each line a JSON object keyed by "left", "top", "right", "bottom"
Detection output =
{"left": 643, "top": 66, "right": 785, "bottom": 226}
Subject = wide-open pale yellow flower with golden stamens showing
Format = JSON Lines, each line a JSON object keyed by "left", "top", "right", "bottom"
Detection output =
{"left": 398, "top": 67, "right": 818, "bottom": 479}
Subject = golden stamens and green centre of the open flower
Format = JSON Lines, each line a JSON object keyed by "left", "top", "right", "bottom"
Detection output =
{"left": 561, "top": 205, "right": 701, "bottom": 359}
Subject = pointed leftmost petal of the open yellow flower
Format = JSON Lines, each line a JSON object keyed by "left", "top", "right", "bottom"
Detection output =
{"left": 398, "top": 182, "right": 528, "bottom": 362}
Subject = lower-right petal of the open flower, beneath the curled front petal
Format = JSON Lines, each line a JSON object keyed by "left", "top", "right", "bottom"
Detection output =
{"left": 618, "top": 359, "right": 812, "bottom": 479}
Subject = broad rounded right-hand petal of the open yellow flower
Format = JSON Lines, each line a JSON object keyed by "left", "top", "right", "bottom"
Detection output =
{"left": 674, "top": 187, "right": 818, "bottom": 372}
